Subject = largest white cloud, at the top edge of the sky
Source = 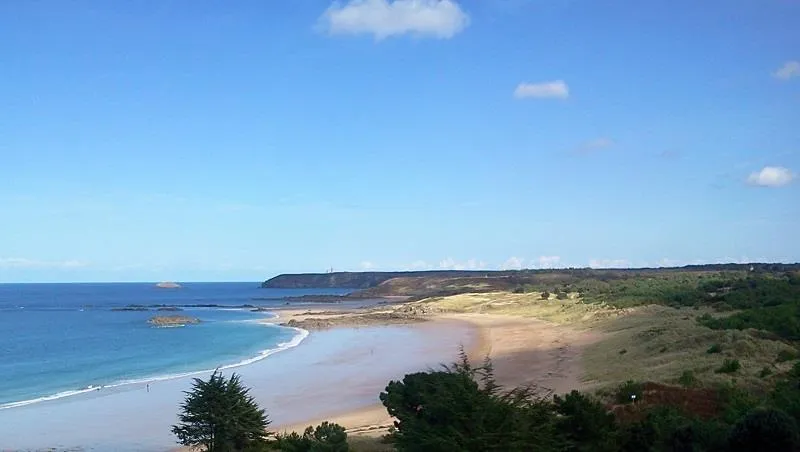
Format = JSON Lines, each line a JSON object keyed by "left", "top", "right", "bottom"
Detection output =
{"left": 320, "top": 0, "right": 469, "bottom": 40}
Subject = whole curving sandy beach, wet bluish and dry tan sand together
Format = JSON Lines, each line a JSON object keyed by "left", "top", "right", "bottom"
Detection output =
{"left": 0, "top": 296, "right": 598, "bottom": 451}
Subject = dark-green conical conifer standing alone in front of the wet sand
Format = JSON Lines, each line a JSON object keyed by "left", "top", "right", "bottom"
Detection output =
{"left": 172, "top": 371, "right": 269, "bottom": 452}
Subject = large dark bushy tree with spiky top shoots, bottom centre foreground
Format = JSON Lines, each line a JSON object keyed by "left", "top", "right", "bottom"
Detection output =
{"left": 380, "top": 355, "right": 565, "bottom": 452}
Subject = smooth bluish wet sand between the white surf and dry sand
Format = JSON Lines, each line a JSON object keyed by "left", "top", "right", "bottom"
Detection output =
{"left": 0, "top": 319, "right": 476, "bottom": 451}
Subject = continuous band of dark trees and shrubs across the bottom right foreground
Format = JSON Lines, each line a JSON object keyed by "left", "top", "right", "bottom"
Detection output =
{"left": 381, "top": 359, "right": 800, "bottom": 452}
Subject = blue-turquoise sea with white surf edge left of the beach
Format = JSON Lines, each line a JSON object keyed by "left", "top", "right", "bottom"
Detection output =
{"left": 0, "top": 282, "right": 348, "bottom": 409}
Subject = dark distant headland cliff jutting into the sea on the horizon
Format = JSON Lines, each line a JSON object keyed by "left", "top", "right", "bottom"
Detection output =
{"left": 261, "top": 270, "right": 498, "bottom": 289}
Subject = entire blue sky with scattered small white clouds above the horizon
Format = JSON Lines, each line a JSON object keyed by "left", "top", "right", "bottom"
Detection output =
{"left": 0, "top": 0, "right": 800, "bottom": 282}
